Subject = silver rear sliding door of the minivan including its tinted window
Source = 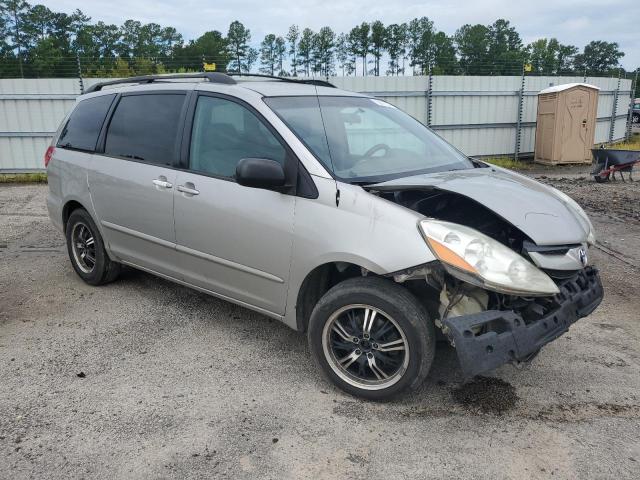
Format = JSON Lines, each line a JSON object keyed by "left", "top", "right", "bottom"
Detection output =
{"left": 89, "top": 92, "right": 186, "bottom": 277}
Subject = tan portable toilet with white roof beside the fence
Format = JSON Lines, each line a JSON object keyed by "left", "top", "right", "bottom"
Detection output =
{"left": 534, "top": 83, "right": 600, "bottom": 165}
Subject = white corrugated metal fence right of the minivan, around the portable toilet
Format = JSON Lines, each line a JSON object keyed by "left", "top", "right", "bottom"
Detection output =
{"left": 331, "top": 75, "right": 631, "bottom": 156}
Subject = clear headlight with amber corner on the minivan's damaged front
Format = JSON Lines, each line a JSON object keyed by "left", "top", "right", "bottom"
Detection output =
{"left": 418, "top": 219, "right": 559, "bottom": 296}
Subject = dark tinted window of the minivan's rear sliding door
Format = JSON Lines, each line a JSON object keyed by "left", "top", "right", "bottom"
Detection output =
{"left": 104, "top": 94, "right": 185, "bottom": 165}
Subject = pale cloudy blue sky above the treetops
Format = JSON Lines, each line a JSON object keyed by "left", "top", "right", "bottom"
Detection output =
{"left": 42, "top": 0, "right": 640, "bottom": 70}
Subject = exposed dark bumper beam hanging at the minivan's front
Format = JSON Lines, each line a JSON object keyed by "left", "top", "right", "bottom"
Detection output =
{"left": 443, "top": 267, "right": 604, "bottom": 378}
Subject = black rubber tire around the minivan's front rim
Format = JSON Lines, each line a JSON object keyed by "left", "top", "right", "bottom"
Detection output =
{"left": 308, "top": 277, "right": 435, "bottom": 400}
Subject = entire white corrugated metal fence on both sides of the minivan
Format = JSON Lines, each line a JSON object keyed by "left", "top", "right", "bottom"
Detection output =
{"left": 0, "top": 75, "right": 631, "bottom": 172}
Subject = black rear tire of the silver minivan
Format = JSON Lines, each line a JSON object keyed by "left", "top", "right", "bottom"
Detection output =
{"left": 65, "top": 208, "right": 120, "bottom": 285}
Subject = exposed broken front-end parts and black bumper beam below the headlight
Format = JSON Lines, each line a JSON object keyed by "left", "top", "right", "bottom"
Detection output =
{"left": 392, "top": 261, "right": 604, "bottom": 378}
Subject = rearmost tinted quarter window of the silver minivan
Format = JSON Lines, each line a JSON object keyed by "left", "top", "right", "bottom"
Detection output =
{"left": 57, "top": 95, "right": 115, "bottom": 152}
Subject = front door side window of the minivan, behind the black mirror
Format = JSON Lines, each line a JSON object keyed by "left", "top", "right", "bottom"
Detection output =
{"left": 189, "top": 96, "right": 287, "bottom": 178}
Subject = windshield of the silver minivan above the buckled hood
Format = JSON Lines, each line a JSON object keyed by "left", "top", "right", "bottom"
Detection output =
{"left": 265, "top": 96, "right": 473, "bottom": 183}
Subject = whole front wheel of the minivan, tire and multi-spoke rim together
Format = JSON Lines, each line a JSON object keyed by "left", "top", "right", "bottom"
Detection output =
{"left": 308, "top": 277, "right": 435, "bottom": 400}
